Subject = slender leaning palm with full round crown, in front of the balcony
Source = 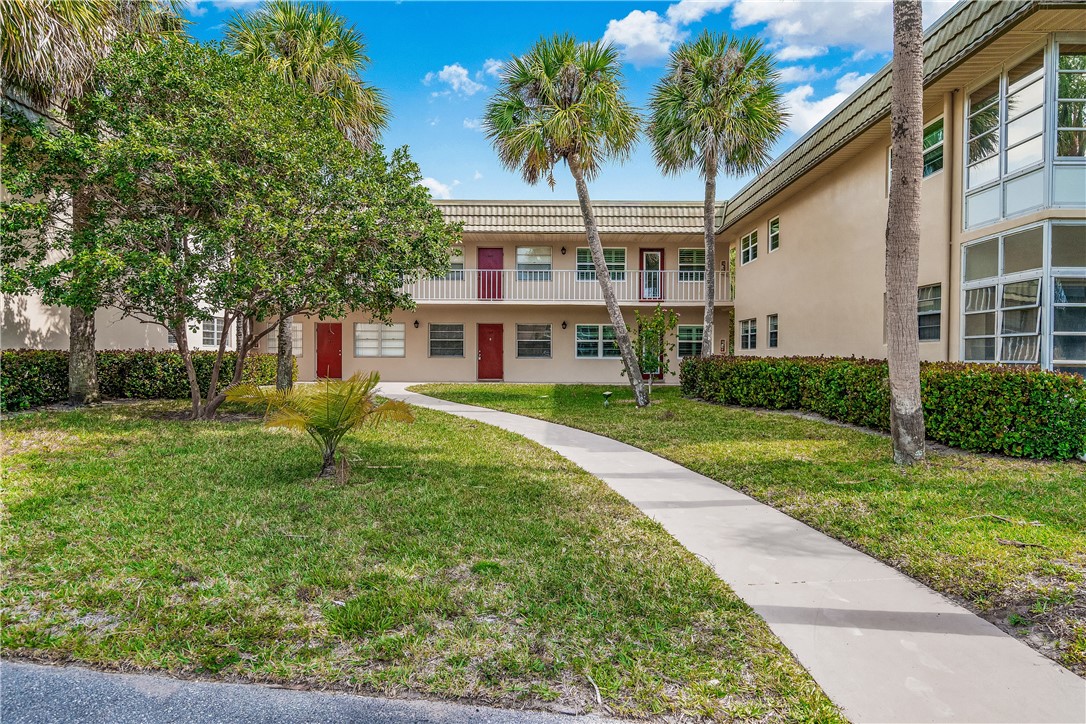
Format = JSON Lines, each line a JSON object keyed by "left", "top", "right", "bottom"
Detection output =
{"left": 483, "top": 35, "right": 648, "bottom": 407}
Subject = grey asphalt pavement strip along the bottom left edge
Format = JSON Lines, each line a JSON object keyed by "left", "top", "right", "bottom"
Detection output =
{"left": 0, "top": 661, "right": 605, "bottom": 724}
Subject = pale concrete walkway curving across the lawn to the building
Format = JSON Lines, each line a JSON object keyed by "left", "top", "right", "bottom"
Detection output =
{"left": 381, "top": 382, "right": 1086, "bottom": 723}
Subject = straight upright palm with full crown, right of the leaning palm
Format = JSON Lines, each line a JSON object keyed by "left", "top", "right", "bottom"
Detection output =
{"left": 648, "top": 30, "right": 788, "bottom": 356}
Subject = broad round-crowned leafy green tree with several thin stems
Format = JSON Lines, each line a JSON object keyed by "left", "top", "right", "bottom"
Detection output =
{"left": 5, "top": 42, "right": 458, "bottom": 419}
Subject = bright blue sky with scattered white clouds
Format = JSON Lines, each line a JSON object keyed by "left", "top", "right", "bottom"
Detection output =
{"left": 186, "top": 0, "right": 951, "bottom": 201}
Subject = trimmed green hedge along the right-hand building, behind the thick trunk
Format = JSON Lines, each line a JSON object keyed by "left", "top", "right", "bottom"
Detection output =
{"left": 680, "top": 356, "right": 1086, "bottom": 460}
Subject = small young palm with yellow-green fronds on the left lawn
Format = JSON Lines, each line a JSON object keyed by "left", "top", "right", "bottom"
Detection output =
{"left": 227, "top": 372, "right": 415, "bottom": 478}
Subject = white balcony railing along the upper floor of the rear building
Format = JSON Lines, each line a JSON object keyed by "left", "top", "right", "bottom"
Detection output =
{"left": 407, "top": 269, "right": 731, "bottom": 305}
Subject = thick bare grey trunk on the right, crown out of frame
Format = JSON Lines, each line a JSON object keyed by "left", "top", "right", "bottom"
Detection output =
{"left": 886, "top": 0, "right": 924, "bottom": 465}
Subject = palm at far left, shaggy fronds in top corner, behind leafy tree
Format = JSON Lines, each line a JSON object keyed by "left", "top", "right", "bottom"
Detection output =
{"left": 0, "top": 0, "right": 185, "bottom": 405}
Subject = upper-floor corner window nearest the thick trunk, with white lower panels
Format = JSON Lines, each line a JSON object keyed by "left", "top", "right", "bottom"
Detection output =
{"left": 965, "top": 50, "right": 1045, "bottom": 227}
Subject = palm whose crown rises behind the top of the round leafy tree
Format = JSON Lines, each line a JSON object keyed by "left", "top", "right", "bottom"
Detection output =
{"left": 226, "top": 0, "right": 389, "bottom": 390}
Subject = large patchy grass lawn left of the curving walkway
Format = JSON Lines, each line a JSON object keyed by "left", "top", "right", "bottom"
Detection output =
{"left": 0, "top": 403, "right": 841, "bottom": 722}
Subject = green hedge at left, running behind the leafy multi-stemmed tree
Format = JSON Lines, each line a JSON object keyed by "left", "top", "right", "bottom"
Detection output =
{"left": 0, "top": 350, "right": 298, "bottom": 411}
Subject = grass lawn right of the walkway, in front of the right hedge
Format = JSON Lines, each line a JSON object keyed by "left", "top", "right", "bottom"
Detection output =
{"left": 415, "top": 384, "right": 1086, "bottom": 675}
